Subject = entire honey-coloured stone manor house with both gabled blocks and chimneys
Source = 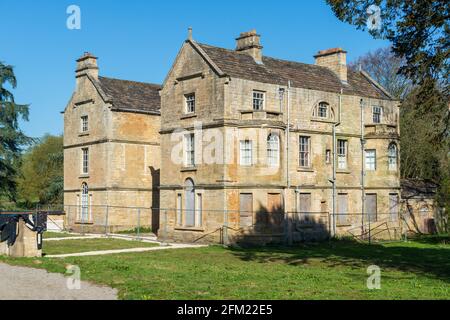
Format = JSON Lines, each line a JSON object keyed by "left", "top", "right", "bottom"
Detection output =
{"left": 64, "top": 31, "right": 436, "bottom": 243}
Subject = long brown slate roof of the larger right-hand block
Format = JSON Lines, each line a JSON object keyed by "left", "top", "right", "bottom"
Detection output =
{"left": 198, "top": 44, "right": 392, "bottom": 100}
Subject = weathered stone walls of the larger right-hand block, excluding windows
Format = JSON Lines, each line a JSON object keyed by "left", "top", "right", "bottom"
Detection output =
{"left": 161, "top": 40, "right": 400, "bottom": 245}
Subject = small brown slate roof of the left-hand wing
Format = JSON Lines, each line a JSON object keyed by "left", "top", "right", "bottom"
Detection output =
{"left": 98, "top": 77, "right": 161, "bottom": 114}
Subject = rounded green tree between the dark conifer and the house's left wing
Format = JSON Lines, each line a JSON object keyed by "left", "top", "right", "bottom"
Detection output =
{"left": 18, "top": 135, "right": 64, "bottom": 207}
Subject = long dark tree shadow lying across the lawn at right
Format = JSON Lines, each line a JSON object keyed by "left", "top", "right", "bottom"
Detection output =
{"left": 229, "top": 239, "right": 450, "bottom": 282}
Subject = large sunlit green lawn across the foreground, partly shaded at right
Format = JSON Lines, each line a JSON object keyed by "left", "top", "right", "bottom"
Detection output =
{"left": 0, "top": 236, "right": 450, "bottom": 299}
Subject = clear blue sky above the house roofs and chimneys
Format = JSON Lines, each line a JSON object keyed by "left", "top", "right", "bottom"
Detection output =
{"left": 0, "top": 0, "right": 388, "bottom": 137}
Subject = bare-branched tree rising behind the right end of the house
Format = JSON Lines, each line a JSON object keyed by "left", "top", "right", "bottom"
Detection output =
{"left": 350, "top": 48, "right": 450, "bottom": 229}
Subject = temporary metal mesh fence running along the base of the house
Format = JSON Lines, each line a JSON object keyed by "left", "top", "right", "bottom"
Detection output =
{"left": 54, "top": 205, "right": 430, "bottom": 244}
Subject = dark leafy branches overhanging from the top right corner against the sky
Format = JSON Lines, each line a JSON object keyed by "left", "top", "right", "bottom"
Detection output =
{"left": 327, "top": 0, "right": 450, "bottom": 87}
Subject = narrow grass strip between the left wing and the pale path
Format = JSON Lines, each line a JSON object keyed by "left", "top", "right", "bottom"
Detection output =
{"left": 42, "top": 238, "right": 158, "bottom": 255}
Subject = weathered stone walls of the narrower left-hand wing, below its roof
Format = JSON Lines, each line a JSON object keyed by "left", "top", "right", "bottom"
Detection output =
{"left": 64, "top": 58, "right": 161, "bottom": 232}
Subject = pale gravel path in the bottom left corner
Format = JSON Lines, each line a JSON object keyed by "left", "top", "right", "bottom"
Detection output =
{"left": 0, "top": 263, "right": 117, "bottom": 300}
